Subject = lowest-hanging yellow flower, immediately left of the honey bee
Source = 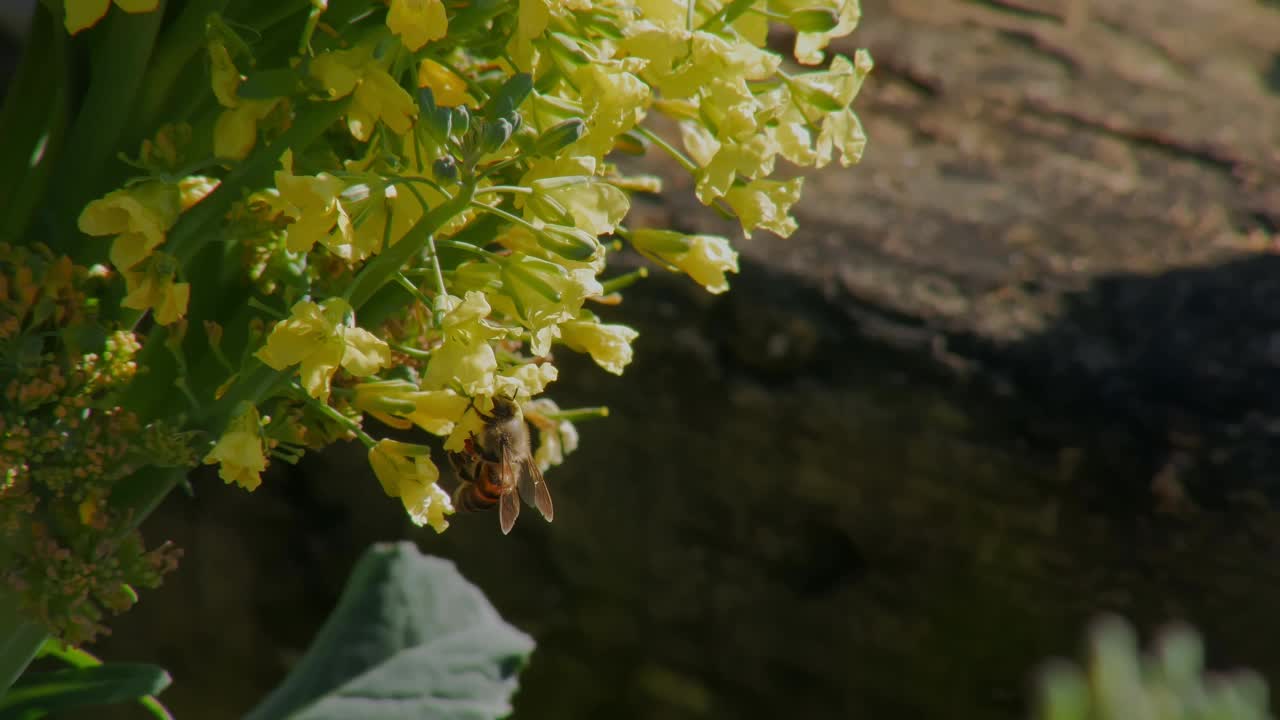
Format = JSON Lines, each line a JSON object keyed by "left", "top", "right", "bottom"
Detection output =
{"left": 369, "top": 439, "right": 453, "bottom": 533}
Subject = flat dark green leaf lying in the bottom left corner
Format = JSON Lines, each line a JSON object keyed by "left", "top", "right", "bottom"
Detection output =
{"left": 0, "top": 662, "right": 170, "bottom": 717}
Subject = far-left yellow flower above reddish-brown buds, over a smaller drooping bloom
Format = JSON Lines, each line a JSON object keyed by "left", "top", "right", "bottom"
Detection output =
{"left": 78, "top": 181, "right": 182, "bottom": 270}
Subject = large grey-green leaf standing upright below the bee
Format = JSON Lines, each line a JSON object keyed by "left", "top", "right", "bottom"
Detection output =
{"left": 246, "top": 542, "right": 534, "bottom": 720}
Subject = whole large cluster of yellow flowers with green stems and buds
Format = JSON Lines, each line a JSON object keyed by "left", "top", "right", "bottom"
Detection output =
{"left": 68, "top": 0, "right": 872, "bottom": 530}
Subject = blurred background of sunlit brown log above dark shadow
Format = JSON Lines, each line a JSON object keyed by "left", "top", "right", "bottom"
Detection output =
{"left": 7, "top": 0, "right": 1280, "bottom": 720}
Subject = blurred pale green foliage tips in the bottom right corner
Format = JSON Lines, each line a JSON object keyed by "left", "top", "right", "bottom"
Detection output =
{"left": 1036, "top": 609, "right": 1272, "bottom": 720}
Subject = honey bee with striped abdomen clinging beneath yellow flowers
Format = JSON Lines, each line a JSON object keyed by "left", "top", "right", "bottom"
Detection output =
{"left": 449, "top": 397, "right": 553, "bottom": 534}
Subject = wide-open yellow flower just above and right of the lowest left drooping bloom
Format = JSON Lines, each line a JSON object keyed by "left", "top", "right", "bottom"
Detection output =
{"left": 257, "top": 297, "right": 392, "bottom": 401}
